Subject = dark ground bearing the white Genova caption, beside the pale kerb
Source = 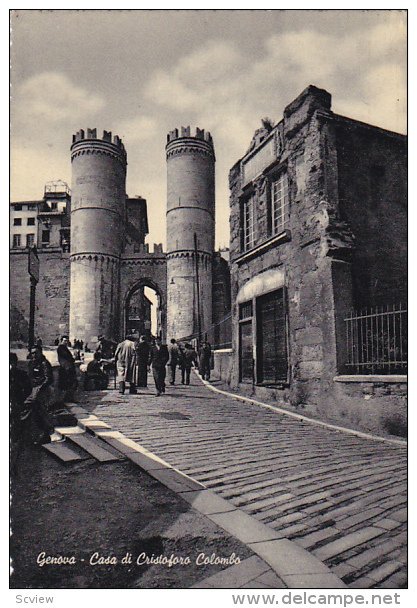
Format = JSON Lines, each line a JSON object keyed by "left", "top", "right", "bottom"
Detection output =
{"left": 10, "top": 420, "right": 272, "bottom": 589}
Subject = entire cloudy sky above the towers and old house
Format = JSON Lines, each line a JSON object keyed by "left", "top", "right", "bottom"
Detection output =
{"left": 11, "top": 10, "right": 406, "bottom": 246}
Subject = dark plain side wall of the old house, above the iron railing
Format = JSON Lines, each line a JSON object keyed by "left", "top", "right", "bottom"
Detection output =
{"left": 335, "top": 120, "right": 407, "bottom": 308}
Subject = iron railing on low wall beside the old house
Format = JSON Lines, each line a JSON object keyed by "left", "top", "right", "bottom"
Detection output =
{"left": 345, "top": 304, "right": 408, "bottom": 374}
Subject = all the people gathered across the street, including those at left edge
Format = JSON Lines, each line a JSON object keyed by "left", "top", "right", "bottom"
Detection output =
{"left": 10, "top": 336, "right": 211, "bottom": 460}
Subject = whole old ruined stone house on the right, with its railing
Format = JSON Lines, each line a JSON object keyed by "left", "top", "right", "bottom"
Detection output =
{"left": 216, "top": 86, "right": 407, "bottom": 428}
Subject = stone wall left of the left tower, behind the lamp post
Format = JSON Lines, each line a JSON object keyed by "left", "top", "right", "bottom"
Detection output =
{"left": 10, "top": 249, "right": 70, "bottom": 344}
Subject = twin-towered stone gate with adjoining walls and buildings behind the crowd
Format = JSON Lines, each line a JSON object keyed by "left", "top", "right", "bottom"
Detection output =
{"left": 10, "top": 127, "right": 230, "bottom": 345}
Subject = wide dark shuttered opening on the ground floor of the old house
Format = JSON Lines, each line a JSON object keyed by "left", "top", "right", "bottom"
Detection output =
{"left": 256, "top": 288, "right": 288, "bottom": 385}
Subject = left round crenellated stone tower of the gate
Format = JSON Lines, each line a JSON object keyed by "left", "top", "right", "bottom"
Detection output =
{"left": 70, "top": 129, "right": 127, "bottom": 342}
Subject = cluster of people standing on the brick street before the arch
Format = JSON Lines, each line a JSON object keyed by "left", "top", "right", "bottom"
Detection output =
{"left": 114, "top": 336, "right": 211, "bottom": 397}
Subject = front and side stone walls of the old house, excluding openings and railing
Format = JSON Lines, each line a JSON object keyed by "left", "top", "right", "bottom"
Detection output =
{"left": 229, "top": 87, "right": 406, "bottom": 430}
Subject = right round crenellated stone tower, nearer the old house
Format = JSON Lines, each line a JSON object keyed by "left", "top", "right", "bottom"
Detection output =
{"left": 166, "top": 127, "right": 215, "bottom": 339}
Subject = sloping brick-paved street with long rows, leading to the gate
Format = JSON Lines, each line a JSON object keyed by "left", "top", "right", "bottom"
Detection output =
{"left": 83, "top": 375, "right": 407, "bottom": 588}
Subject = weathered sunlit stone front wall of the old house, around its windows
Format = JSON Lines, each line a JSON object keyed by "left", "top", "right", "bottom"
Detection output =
{"left": 230, "top": 85, "right": 337, "bottom": 404}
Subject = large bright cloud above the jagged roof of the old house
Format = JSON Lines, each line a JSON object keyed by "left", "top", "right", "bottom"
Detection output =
{"left": 145, "top": 14, "right": 406, "bottom": 142}
